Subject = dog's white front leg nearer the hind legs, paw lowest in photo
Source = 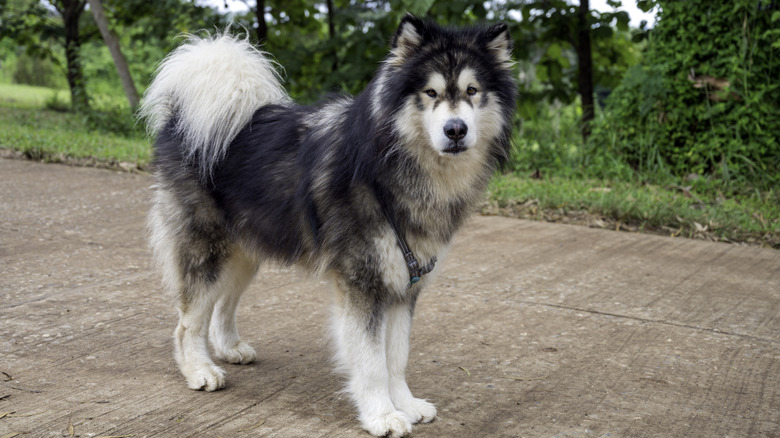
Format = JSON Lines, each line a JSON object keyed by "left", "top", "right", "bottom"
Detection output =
{"left": 331, "top": 282, "right": 412, "bottom": 437}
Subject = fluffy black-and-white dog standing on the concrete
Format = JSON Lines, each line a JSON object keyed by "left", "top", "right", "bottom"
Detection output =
{"left": 140, "top": 15, "right": 517, "bottom": 437}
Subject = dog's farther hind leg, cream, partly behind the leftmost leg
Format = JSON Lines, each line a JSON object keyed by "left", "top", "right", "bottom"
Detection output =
{"left": 209, "top": 250, "right": 257, "bottom": 364}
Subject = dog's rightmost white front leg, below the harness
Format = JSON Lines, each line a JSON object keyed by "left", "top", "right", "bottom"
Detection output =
{"left": 387, "top": 299, "right": 436, "bottom": 423}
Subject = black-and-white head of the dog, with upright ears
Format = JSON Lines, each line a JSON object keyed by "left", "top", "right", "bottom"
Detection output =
{"left": 385, "top": 15, "right": 514, "bottom": 157}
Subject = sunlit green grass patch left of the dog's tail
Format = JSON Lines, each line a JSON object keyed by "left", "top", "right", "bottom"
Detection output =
{"left": 0, "top": 107, "right": 151, "bottom": 168}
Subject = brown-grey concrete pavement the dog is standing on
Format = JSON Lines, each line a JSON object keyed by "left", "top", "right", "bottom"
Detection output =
{"left": 0, "top": 160, "right": 780, "bottom": 438}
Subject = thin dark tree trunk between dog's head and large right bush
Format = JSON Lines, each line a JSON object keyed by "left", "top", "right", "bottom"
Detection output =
{"left": 575, "top": 0, "right": 595, "bottom": 141}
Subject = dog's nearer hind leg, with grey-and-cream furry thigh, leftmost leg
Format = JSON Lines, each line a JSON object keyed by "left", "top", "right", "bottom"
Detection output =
{"left": 149, "top": 183, "right": 237, "bottom": 391}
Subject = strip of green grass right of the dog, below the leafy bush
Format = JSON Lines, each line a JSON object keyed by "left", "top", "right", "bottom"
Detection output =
{"left": 486, "top": 175, "right": 780, "bottom": 249}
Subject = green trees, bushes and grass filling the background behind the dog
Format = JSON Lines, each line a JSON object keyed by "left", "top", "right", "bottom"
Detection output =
{"left": 0, "top": 0, "right": 780, "bottom": 248}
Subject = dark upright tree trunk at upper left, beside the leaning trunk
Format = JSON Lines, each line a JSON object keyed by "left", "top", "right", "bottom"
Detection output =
{"left": 58, "top": 0, "right": 89, "bottom": 111}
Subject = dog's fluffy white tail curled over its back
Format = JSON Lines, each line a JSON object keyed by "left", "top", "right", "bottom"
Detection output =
{"left": 139, "top": 31, "right": 289, "bottom": 177}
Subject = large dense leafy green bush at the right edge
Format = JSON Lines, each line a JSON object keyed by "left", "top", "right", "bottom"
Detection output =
{"left": 589, "top": 0, "right": 780, "bottom": 189}
